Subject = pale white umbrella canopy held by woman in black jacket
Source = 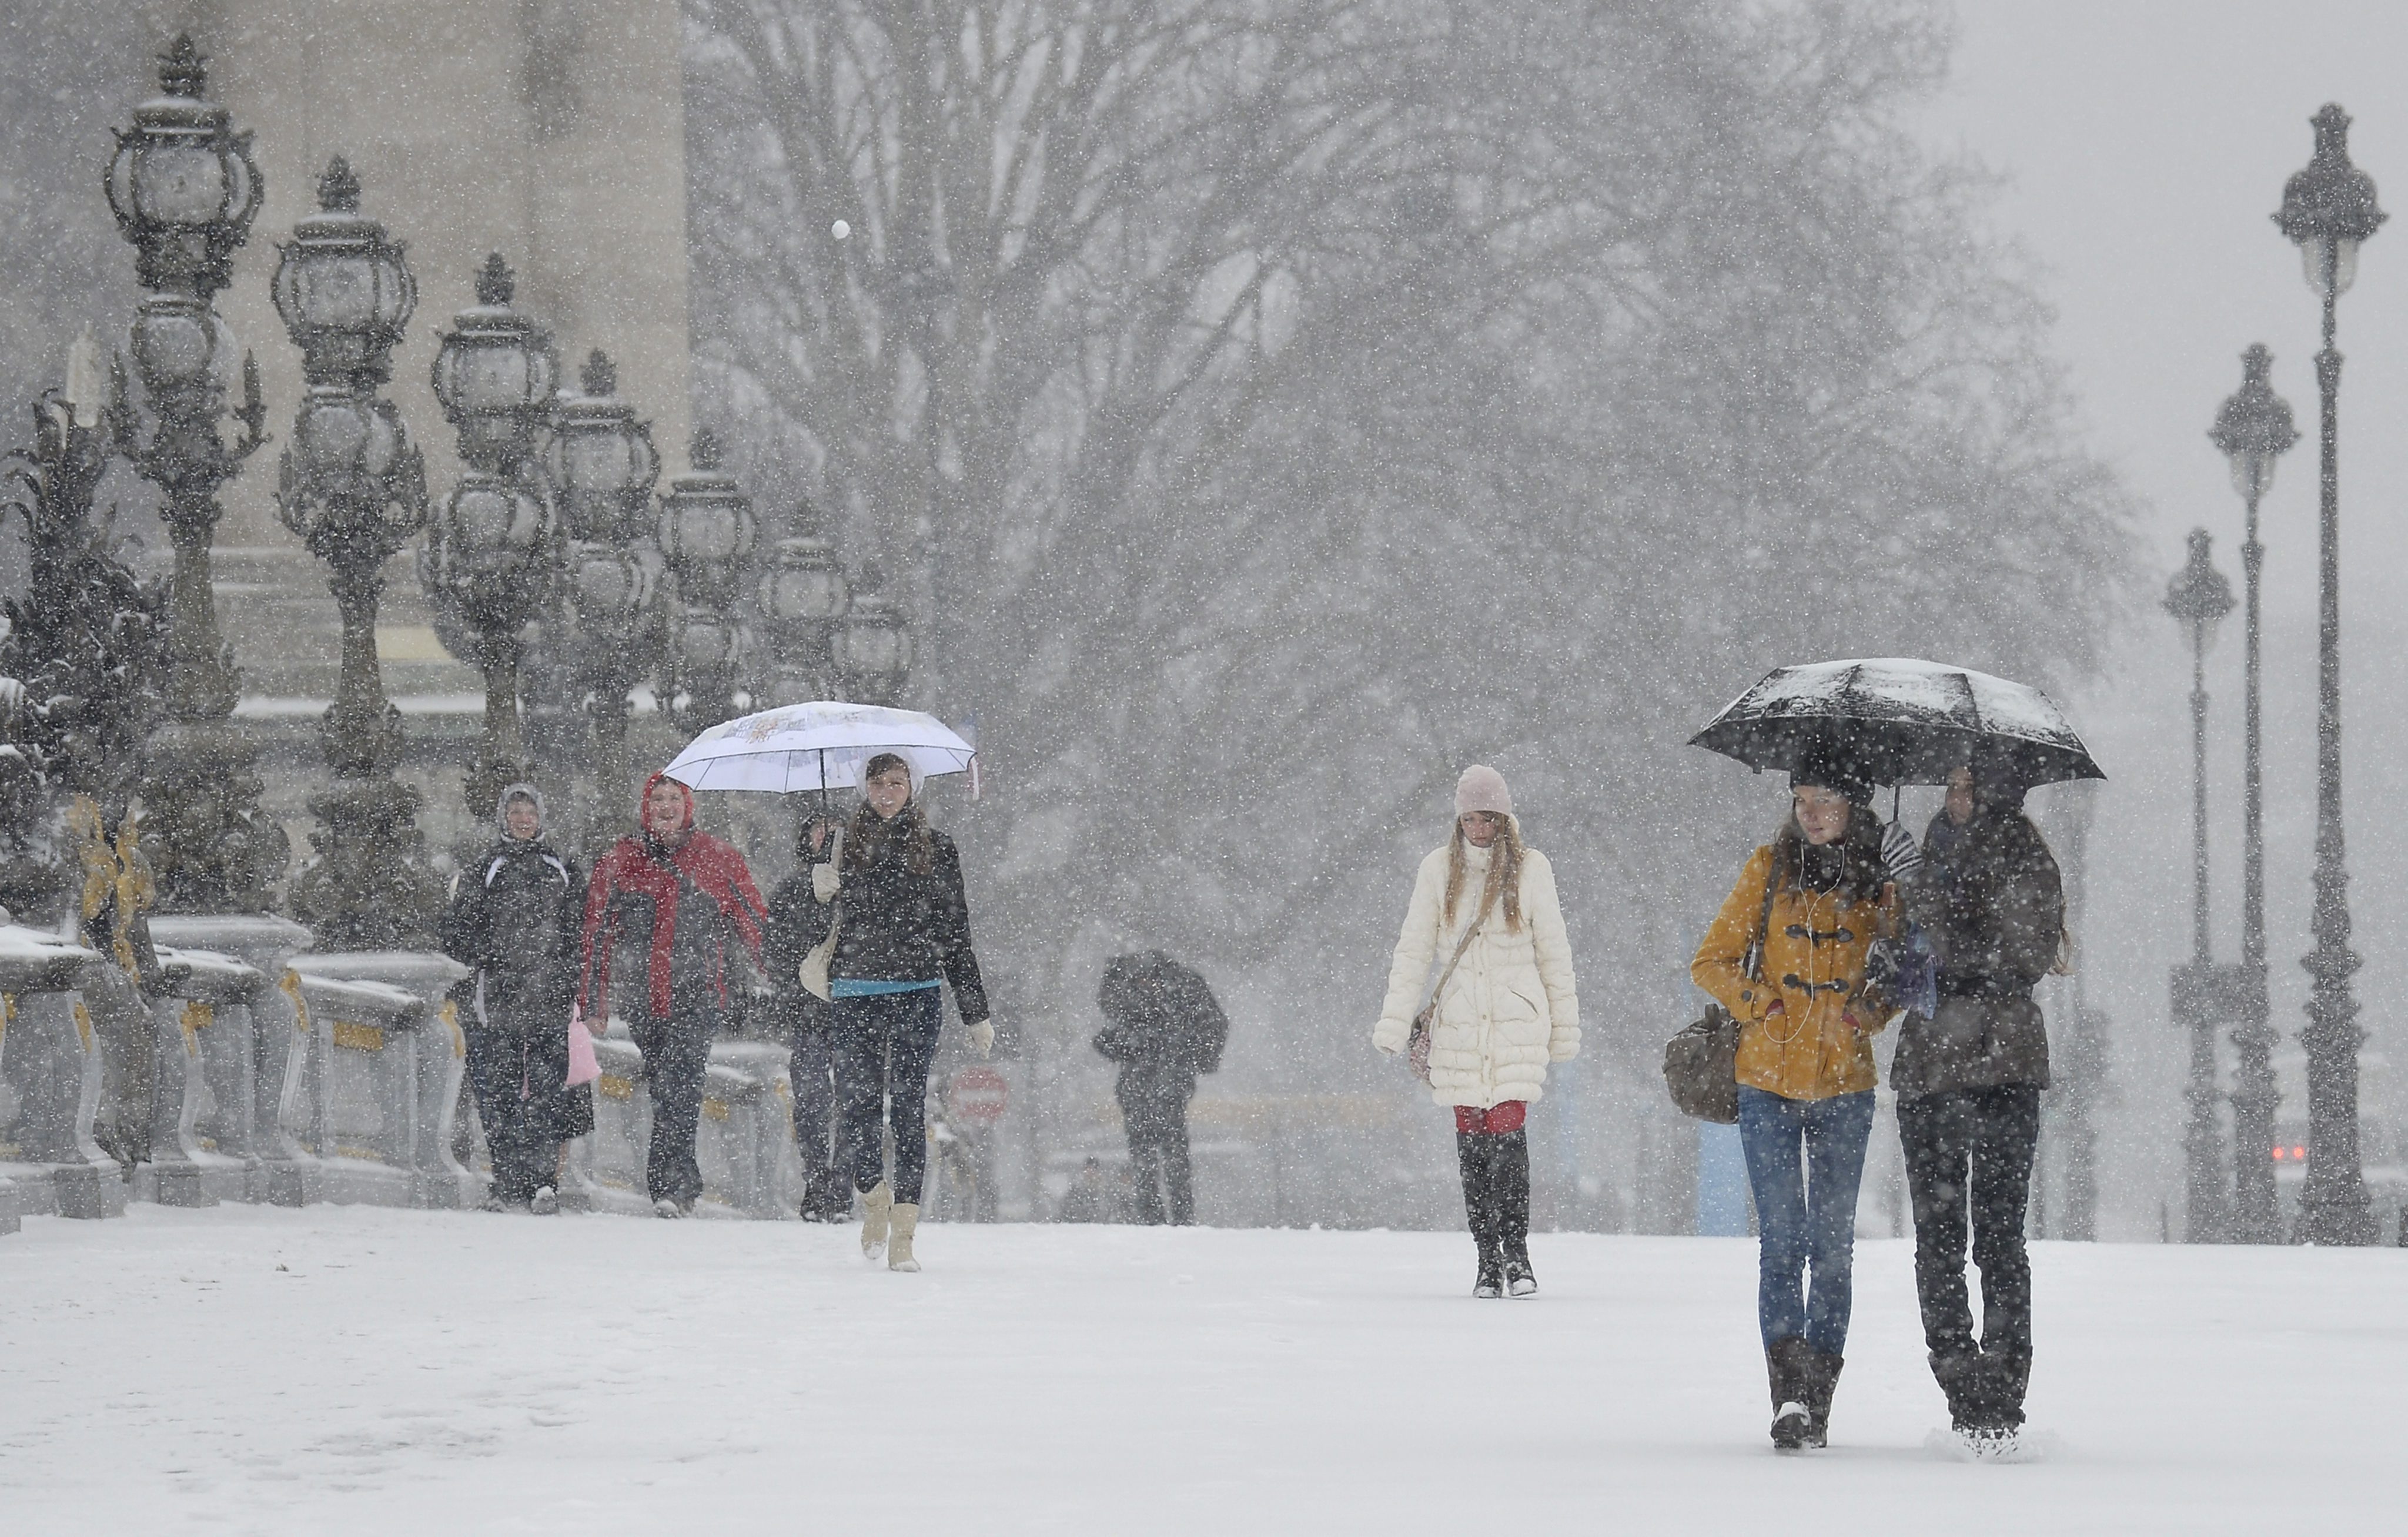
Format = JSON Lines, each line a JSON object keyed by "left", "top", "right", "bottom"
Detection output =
{"left": 662, "top": 701, "right": 978, "bottom": 795}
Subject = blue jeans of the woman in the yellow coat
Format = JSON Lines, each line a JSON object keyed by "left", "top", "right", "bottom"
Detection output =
{"left": 1738, "top": 1084, "right": 1874, "bottom": 1357}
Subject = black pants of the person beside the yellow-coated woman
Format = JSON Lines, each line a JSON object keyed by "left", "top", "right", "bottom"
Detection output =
{"left": 1898, "top": 1087, "right": 2039, "bottom": 1368}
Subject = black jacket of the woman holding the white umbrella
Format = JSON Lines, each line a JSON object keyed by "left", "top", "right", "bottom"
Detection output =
{"left": 814, "top": 829, "right": 987, "bottom": 1024}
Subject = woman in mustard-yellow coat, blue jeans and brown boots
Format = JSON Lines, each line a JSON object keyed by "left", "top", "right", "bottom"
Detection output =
{"left": 1690, "top": 749, "right": 1900, "bottom": 1450}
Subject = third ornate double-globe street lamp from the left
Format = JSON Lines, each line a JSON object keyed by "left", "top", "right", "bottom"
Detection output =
{"left": 419, "top": 253, "right": 558, "bottom": 814}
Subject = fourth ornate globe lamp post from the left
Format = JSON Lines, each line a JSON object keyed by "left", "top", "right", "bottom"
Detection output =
{"left": 544, "top": 349, "right": 662, "bottom": 848}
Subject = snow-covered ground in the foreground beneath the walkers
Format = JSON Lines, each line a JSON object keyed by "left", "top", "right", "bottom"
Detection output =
{"left": 0, "top": 1207, "right": 2408, "bottom": 1537}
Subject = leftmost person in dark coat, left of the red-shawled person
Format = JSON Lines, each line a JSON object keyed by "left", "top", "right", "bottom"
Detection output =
{"left": 443, "top": 783, "right": 593, "bottom": 1217}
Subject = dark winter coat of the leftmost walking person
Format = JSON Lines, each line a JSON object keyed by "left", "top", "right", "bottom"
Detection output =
{"left": 443, "top": 838, "right": 585, "bottom": 1033}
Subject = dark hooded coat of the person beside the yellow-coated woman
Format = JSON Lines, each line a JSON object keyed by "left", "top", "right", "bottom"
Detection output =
{"left": 1890, "top": 809, "right": 2066, "bottom": 1099}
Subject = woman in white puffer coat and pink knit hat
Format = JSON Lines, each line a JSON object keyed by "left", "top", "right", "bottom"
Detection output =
{"left": 1370, "top": 764, "right": 1580, "bottom": 1296}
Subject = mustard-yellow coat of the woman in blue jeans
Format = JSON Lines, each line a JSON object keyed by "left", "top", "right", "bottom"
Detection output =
{"left": 1688, "top": 846, "right": 1895, "bottom": 1099}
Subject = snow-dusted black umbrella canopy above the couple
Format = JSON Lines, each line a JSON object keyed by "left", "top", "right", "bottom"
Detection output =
{"left": 1690, "top": 658, "right": 2107, "bottom": 785}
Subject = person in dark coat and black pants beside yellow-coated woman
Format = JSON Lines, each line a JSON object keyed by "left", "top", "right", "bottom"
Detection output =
{"left": 1890, "top": 749, "right": 2066, "bottom": 1443}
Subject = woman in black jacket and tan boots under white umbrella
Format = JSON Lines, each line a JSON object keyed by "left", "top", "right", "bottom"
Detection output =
{"left": 811, "top": 752, "right": 995, "bottom": 1270}
